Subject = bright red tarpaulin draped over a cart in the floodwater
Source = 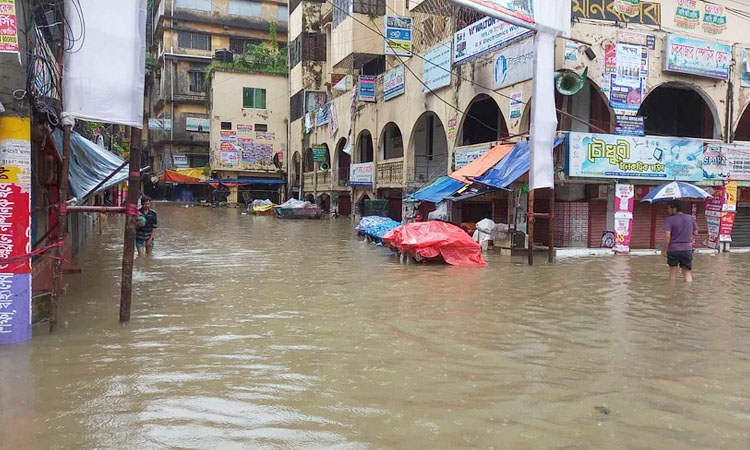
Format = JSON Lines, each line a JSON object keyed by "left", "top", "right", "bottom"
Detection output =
{"left": 383, "top": 221, "right": 487, "bottom": 266}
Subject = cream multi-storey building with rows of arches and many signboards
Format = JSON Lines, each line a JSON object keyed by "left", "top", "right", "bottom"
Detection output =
{"left": 289, "top": 0, "right": 750, "bottom": 248}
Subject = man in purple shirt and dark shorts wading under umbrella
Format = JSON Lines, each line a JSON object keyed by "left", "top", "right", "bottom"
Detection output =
{"left": 661, "top": 200, "right": 698, "bottom": 283}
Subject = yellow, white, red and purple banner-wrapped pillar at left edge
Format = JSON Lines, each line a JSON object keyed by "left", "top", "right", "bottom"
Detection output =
{"left": 0, "top": 116, "right": 31, "bottom": 344}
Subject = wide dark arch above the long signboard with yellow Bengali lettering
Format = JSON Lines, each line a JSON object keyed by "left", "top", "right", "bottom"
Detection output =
{"left": 638, "top": 82, "right": 721, "bottom": 139}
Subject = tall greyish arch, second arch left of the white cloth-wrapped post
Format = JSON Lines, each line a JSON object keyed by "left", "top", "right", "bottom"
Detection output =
{"left": 408, "top": 111, "right": 448, "bottom": 183}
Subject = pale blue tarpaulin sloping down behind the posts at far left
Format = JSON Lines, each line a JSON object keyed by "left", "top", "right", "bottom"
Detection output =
{"left": 52, "top": 128, "right": 128, "bottom": 198}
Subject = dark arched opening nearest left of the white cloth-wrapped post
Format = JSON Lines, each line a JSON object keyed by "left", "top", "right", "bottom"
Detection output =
{"left": 457, "top": 94, "right": 508, "bottom": 145}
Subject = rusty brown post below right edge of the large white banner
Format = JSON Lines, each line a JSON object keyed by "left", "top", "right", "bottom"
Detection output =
{"left": 120, "top": 127, "right": 141, "bottom": 323}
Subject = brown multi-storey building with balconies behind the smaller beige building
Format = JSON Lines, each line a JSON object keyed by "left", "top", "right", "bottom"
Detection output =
{"left": 145, "top": 0, "right": 288, "bottom": 174}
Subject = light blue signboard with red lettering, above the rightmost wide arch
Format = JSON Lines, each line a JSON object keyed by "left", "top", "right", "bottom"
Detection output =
{"left": 664, "top": 35, "right": 732, "bottom": 80}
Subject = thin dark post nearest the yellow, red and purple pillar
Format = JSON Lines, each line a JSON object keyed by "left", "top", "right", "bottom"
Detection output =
{"left": 49, "top": 125, "right": 73, "bottom": 333}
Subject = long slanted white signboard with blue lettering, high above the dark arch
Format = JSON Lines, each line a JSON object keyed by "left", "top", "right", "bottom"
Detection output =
{"left": 453, "top": 17, "right": 533, "bottom": 65}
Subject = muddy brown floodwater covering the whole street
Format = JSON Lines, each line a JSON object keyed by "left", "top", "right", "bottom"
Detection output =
{"left": 0, "top": 203, "right": 750, "bottom": 450}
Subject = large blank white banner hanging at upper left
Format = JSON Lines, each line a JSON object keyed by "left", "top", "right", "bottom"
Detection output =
{"left": 63, "top": 0, "right": 146, "bottom": 128}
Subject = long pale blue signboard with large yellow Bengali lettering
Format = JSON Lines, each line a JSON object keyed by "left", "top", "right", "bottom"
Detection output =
{"left": 568, "top": 133, "right": 703, "bottom": 183}
